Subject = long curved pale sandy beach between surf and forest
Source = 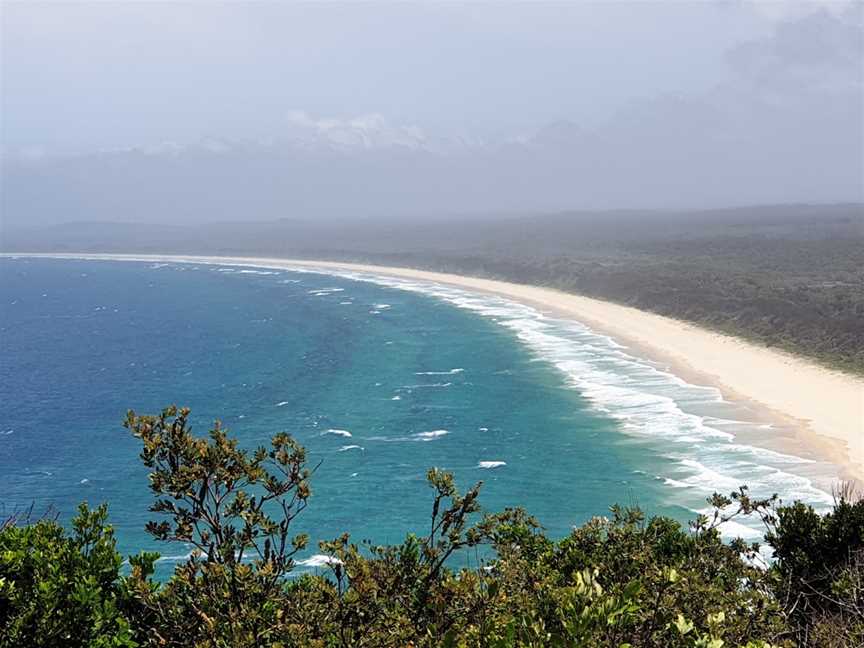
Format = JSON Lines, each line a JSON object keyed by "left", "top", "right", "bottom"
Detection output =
{"left": 8, "top": 253, "right": 864, "bottom": 482}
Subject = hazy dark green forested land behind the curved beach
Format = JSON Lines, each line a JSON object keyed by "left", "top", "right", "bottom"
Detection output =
{"left": 2, "top": 204, "right": 864, "bottom": 373}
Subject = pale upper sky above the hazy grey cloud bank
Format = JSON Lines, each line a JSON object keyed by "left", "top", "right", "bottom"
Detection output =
{"left": 2, "top": 1, "right": 860, "bottom": 151}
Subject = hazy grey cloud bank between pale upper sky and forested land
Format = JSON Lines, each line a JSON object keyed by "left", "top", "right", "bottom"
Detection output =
{"left": 2, "top": 6, "right": 864, "bottom": 224}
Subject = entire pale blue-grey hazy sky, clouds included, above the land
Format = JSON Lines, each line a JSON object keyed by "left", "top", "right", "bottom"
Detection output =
{"left": 0, "top": 0, "right": 864, "bottom": 218}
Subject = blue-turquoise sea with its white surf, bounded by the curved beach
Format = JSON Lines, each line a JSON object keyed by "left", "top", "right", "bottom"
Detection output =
{"left": 0, "top": 258, "right": 827, "bottom": 565}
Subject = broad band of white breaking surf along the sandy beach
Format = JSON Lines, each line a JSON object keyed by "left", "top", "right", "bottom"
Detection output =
{"left": 302, "top": 268, "right": 831, "bottom": 535}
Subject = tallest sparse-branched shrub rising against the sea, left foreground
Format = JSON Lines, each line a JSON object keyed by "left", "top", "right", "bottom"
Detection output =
{"left": 125, "top": 407, "right": 311, "bottom": 646}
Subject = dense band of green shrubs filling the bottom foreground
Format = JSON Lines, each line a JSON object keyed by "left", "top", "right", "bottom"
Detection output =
{"left": 0, "top": 407, "right": 864, "bottom": 648}
